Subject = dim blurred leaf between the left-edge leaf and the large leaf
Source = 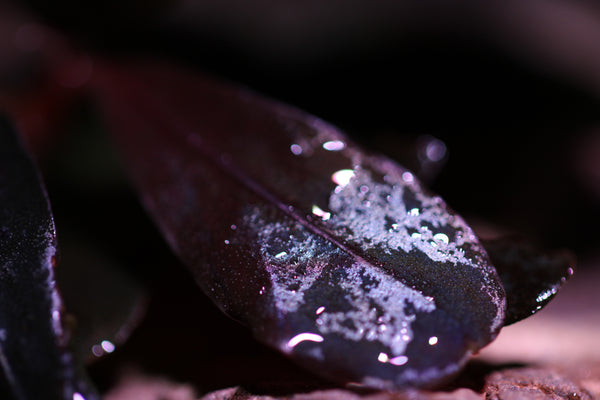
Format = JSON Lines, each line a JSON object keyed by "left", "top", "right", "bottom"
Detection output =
{"left": 56, "top": 236, "right": 147, "bottom": 361}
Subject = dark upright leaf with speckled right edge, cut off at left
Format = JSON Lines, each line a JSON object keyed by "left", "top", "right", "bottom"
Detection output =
{"left": 0, "top": 119, "right": 96, "bottom": 400}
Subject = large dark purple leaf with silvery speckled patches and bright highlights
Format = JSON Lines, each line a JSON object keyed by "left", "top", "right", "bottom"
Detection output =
{"left": 96, "top": 63, "right": 504, "bottom": 388}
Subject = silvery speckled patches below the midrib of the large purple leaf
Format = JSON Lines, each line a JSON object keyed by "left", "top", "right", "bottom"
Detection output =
{"left": 247, "top": 206, "right": 435, "bottom": 356}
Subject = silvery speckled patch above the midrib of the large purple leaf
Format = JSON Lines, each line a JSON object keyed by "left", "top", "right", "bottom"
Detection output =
{"left": 328, "top": 168, "right": 477, "bottom": 266}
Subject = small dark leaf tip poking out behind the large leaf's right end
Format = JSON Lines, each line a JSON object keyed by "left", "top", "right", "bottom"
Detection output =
{"left": 482, "top": 236, "right": 575, "bottom": 325}
